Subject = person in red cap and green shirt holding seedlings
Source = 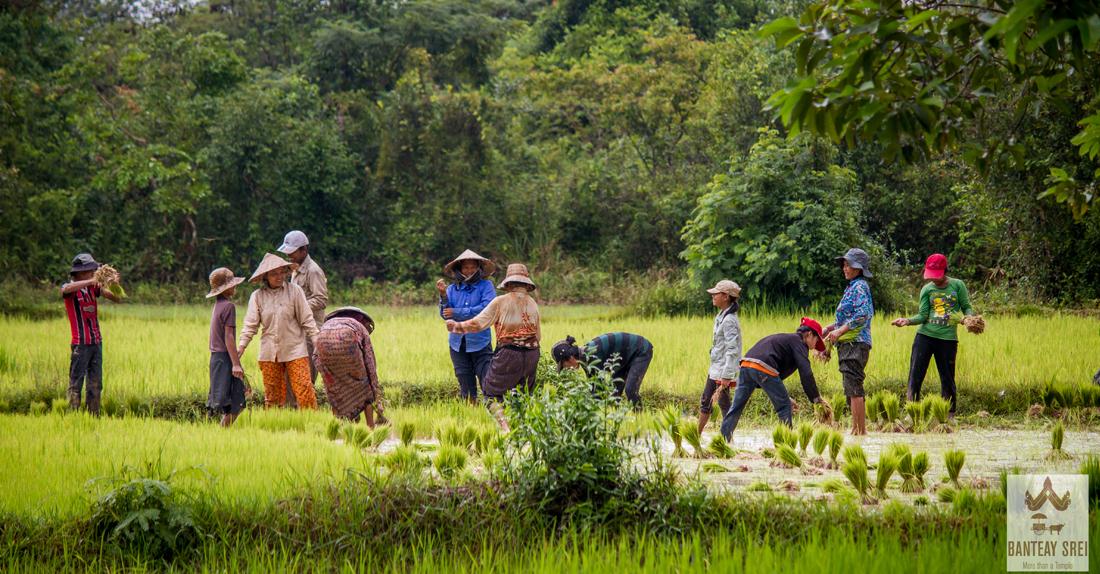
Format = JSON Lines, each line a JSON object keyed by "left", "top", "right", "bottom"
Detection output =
{"left": 893, "top": 253, "right": 975, "bottom": 418}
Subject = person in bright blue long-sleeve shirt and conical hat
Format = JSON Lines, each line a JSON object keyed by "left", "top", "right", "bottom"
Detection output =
{"left": 436, "top": 250, "right": 496, "bottom": 402}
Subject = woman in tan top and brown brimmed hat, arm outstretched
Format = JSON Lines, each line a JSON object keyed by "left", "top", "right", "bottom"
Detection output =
{"left": 447, "top": 263, "right": 542, "bottom": 431}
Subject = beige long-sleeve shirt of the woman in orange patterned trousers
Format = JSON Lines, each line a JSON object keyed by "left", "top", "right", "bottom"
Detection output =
{"left": 238, "top": 283, "right": 318, "bottom": 363}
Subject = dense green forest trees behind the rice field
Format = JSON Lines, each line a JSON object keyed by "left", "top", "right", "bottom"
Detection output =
{"left": 0, "top": 0, "right": 1100, "bottom": 303}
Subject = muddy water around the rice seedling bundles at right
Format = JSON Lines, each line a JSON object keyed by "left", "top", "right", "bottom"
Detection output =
{"left": 662, "top": 428, "right": 1100, "bottom": 501}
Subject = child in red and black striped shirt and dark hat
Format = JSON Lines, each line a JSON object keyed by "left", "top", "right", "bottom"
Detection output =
{"left": 62, "top": 253, "right": 119, "bottom": 416}
